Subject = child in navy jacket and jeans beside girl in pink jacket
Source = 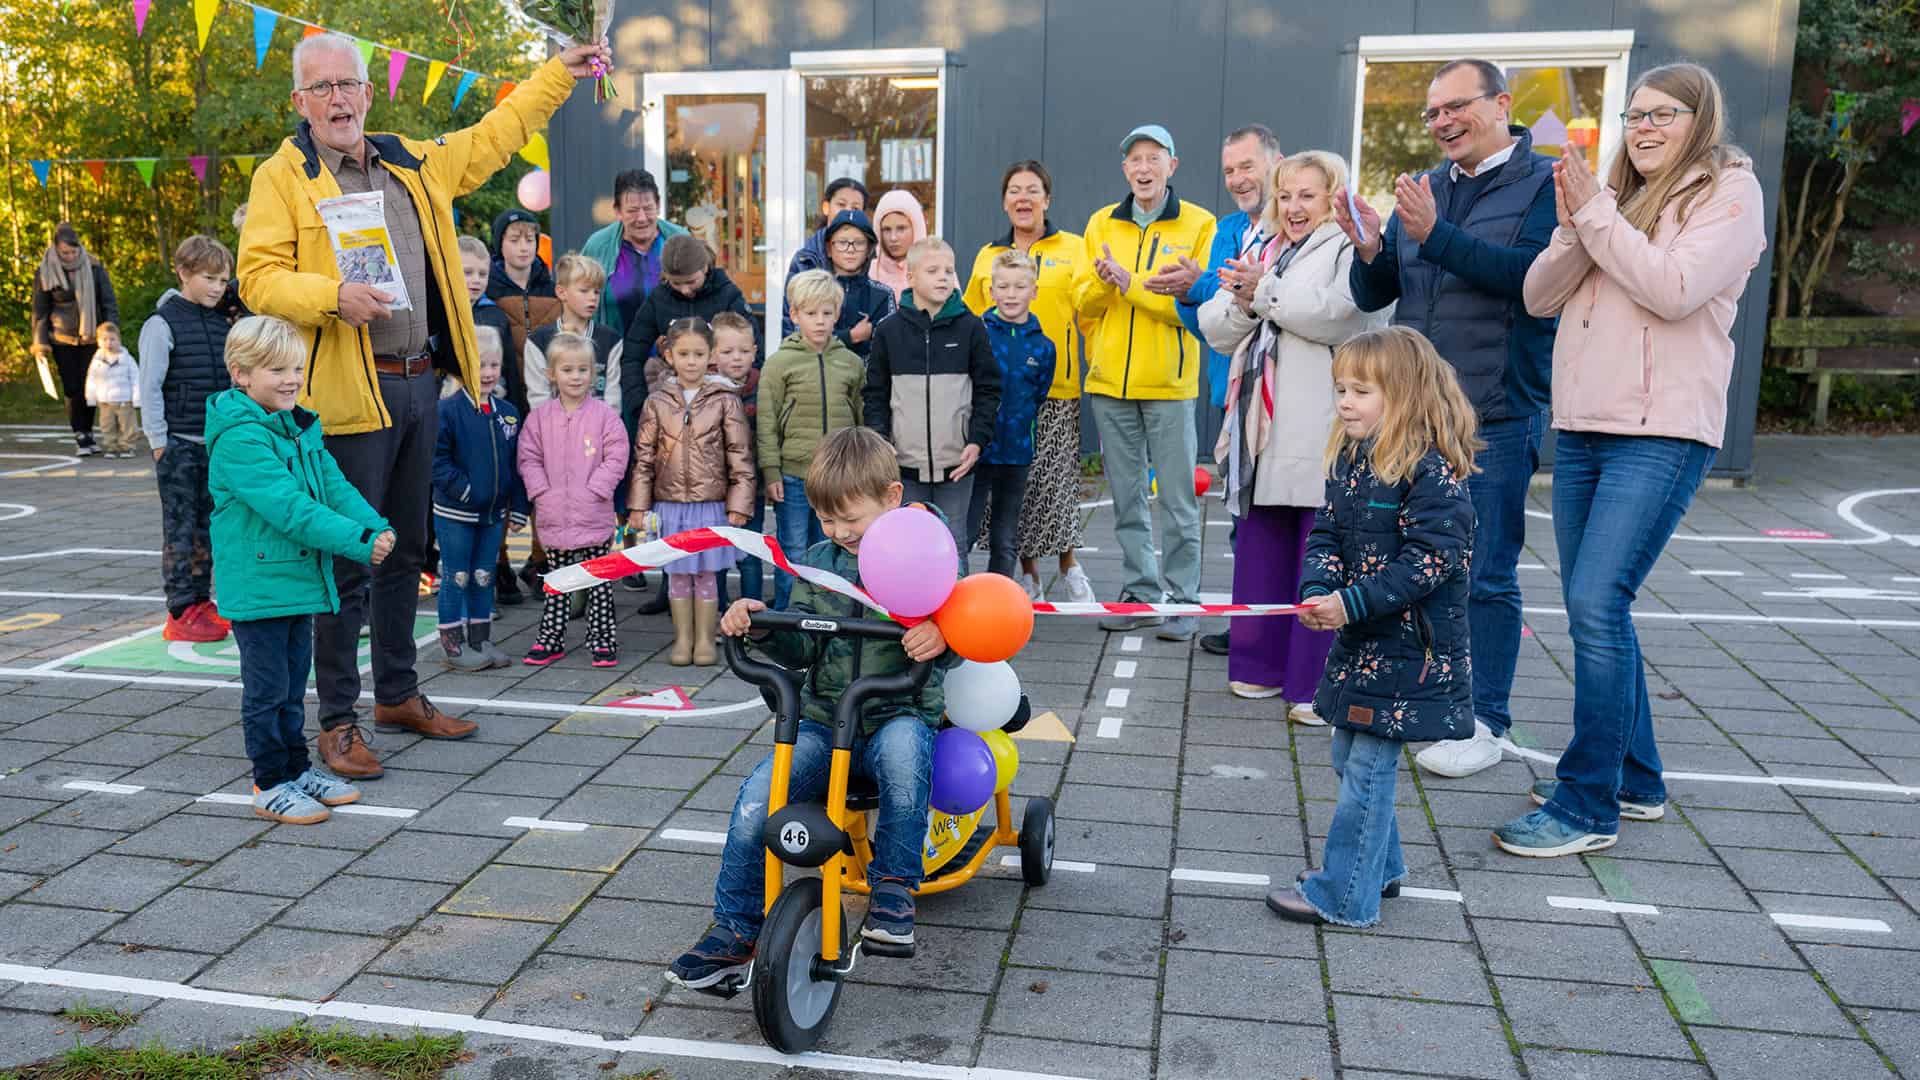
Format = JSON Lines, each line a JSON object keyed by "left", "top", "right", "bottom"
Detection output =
{"left": 434, "top": 327, "right": 526, "bottom": 671}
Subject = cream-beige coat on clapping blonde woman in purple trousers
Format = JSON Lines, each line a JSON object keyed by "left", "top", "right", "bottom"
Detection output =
{"left": 1200, "top": 221, "right": 1394, "bottom": 507}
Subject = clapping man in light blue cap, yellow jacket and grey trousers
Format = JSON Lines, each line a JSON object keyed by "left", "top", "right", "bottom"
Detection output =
{"left": 1073, "top": 123, "right": 1213, "bottom": 642}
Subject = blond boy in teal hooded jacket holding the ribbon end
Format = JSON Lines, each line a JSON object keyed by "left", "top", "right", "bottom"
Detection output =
{"left": 207, "top": 315, "right": 394, "bottom": 824}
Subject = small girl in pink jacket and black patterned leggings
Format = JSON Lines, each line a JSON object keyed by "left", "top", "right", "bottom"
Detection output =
{"left": 520, "top": 334, "right": 630, "bottom": 667}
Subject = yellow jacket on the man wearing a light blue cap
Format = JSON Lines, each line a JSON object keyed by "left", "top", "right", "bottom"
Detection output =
{"left": 1073, "top": 188, "right": 1213, "bottom": 402}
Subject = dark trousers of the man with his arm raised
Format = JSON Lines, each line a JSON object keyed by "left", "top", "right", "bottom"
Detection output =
{"left": 313, "top": 365, "right": 440, "bottom": 730}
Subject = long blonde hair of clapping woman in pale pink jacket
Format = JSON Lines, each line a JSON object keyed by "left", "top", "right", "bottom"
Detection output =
{"left": 1607, "top": 63, "right": 1747, "bottom": 236}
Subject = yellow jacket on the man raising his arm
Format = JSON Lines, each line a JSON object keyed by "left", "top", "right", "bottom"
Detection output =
{"left": 236, "top": 60, "right": 574, "bottom": 434}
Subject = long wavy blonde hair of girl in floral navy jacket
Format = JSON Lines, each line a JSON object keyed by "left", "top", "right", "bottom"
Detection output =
{"left": 1325, "top": 327, "right": 1486, "bottom": 484}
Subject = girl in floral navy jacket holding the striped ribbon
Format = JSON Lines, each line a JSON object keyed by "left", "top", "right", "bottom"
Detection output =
{"left": 1267, "top": 327, "right": 1482, "bottom": 926}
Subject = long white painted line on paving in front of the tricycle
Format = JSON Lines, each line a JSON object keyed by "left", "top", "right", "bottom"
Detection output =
{"left": 0, "top": 957, "right": 1113, "bottom": 1080}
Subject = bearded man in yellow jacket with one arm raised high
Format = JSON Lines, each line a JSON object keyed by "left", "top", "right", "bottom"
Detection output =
{"left": 238, "top": 33, "right": 609, "bottom": 780}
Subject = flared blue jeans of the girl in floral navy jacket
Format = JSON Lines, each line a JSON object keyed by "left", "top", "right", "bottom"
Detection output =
{"left": 1300, "top": 728, "right": 1407, "bottom": 926}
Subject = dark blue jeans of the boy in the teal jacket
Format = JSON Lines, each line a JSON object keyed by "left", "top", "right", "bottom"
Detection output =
{"left": 234, "top": 615, "right": 313, "bottom": 792}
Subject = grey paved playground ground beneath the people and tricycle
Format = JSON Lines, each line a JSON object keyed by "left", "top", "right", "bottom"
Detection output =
{"left": 0, "top": 430, "right": 1920, "bottom": 1080}
